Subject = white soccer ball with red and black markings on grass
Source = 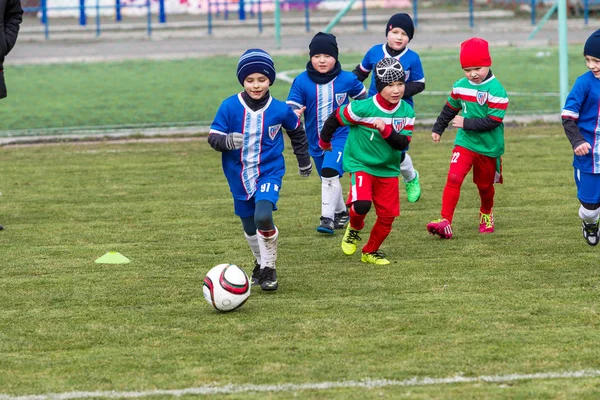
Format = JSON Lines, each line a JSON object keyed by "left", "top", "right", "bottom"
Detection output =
{"left": 202, "top": 264, "right": 250, "bottom": 311}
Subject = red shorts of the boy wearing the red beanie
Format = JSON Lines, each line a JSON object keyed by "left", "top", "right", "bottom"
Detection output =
{"left": 448, "top": 146, "right": 502, "bottom": 186}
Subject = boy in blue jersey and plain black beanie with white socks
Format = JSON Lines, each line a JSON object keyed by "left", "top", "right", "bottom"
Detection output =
{"left": 287, "top": 32, "right": 367, "bottom": 235}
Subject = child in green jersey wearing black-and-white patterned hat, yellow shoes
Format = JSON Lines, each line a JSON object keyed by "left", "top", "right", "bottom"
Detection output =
{"left": 319, "top": 58, "right": 415, "bottom": 265}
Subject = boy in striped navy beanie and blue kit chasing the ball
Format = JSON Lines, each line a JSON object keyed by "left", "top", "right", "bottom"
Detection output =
{"left": 208, "top": 49, "right": 312, "bottom": 290}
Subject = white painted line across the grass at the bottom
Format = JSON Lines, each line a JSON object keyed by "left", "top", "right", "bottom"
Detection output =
{"left": 0, "top": 369, "right": 600, "bottom": 400}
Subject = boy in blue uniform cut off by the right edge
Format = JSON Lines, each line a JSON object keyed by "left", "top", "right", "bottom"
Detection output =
{"left": 562, "top": 29, "right": 600, "bottom": 246}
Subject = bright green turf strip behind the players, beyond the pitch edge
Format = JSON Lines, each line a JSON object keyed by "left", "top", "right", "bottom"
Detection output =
{"left": 0, "top": 46, "right": 585, "bottom": 136}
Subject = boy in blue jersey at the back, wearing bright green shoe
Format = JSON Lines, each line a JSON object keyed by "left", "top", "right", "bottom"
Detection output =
{"left": 353, "top": 13, "right": 425, "bottom": 203}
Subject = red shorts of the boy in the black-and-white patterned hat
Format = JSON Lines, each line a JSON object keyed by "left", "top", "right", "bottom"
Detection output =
{"left": 346, "top": 172, "right": 400, "bottom": 217}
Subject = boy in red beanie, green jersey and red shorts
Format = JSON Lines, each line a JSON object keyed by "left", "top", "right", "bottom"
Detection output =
{"left": 427, "top": 38, "right": 508, "bottom": 239}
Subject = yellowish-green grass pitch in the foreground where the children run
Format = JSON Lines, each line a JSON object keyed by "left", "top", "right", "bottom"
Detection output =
{"left": 0, "top": 125, "right": 600, "bottom": 399}
